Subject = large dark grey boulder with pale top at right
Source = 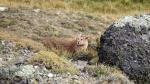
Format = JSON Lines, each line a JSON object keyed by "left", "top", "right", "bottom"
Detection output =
{"left": 99, "top": 14, "right": 150, "bottom": 84}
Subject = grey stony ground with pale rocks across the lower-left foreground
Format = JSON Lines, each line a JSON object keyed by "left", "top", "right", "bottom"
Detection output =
{"left": 0, "top": 40, "right": 131, "bottom": 84}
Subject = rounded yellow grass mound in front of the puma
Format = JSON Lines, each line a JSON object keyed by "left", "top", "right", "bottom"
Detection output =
{"left": 29, "top": 51, "right": 77, "bottom": 74}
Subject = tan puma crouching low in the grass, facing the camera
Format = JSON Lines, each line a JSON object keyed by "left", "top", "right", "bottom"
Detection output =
{"left": 43, "top": 34, "right": 88, "bottom": 52}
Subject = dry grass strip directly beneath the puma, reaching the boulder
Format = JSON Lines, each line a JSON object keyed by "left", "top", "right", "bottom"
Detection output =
{"left": 48, "top": 45, "right": 99, "bottom": 65}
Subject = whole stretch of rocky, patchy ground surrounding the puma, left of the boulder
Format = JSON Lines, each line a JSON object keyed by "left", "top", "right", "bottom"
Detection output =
{"left": 0, "top": 8, "right": 133, "bottom": 84}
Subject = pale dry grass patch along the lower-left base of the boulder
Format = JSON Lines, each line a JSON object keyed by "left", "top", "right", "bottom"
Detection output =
{"left": 85, "top": 64, "right": 133, "bottom": 84}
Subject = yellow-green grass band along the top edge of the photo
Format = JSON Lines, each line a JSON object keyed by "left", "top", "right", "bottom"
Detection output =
{"left": 0, "top": 0, "right": 150, "bottom": 16}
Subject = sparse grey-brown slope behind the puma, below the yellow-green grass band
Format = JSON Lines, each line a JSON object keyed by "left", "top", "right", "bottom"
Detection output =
{"left": 0, "top": 8, "right": 112, "bottom": 39}
